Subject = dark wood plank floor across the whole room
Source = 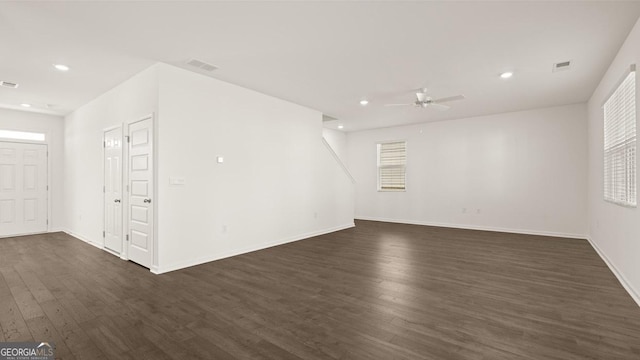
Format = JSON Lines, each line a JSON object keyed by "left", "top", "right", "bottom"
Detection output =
{"left": 0, "top": 221, "right": 640, "bottom": 360}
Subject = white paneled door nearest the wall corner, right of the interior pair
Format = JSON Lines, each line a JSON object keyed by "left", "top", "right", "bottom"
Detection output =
{"left": 128, "top": 118, "right": 154, "bottom": 268}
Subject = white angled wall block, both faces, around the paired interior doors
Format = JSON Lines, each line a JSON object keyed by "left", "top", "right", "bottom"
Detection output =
{"left": 64, "top": 64, "right": 353, "bottom": 273}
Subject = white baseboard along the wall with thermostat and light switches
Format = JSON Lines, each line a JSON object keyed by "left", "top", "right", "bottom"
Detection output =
{"left": 151, "top": 223, "right": 355, "bottom": 274}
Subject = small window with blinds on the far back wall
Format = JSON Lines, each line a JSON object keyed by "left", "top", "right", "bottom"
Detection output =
{"left": 378, "top": 141, "right": 407, "bottom": 191}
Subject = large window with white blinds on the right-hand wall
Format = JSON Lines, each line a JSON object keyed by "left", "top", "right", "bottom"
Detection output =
{"left": 604, "top": 66, "right": 637, "bottom": 206}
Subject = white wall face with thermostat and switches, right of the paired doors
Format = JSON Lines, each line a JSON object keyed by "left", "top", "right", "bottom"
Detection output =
{"left": 157, "top": 64, "right": 354, "bottom": 272}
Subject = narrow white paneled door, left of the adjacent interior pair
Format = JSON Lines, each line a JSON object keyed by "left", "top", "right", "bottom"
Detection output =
{"left": 104, "top": 127, "right": 122, "bottom": 254}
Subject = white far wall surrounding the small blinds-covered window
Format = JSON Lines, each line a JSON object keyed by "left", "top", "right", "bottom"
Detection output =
{"left": 347, "top": 104, "right": 587, "bottom": 238}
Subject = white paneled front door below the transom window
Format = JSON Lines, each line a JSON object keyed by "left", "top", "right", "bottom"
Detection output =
{"left": 0, "top": 142, "right": 47, "bottom": 236}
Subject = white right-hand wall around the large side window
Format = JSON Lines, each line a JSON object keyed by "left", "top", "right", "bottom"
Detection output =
{"left": 588, "top": 16, "right": 640, "bottom": 304}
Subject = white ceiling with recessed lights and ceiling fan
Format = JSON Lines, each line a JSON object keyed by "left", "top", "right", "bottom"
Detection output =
{"left": 0, "top": 1, "right": 640, "bottom": 131}
